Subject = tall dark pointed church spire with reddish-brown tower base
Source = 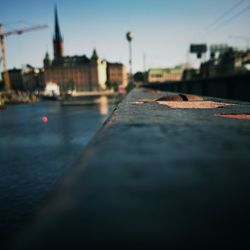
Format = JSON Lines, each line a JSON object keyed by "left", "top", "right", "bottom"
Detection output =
{"left": 53, "top": 6, "right": 63, "bottom": 59}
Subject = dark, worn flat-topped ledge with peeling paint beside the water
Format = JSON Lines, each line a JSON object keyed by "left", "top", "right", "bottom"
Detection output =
{"left": 10, "top": 89, "right": 250, "bottom": 249}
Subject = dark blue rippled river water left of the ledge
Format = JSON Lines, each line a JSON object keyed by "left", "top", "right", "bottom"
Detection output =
{"left": 0, "top": 101, "right": 111, "bottom": 247}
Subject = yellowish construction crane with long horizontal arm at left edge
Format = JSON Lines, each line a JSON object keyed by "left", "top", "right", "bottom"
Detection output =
{"left": 0, "top": 24, "right": 48, "bottom": 91}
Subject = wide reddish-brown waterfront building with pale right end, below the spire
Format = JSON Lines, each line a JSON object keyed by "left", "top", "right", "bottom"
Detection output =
{"left": 44, "top": 50, "right": 107, "bottom": 92}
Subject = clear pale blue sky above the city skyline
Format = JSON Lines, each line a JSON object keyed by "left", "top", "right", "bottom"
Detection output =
{"left": 0, "top": 0, "right": 250, "bottom": 72}
